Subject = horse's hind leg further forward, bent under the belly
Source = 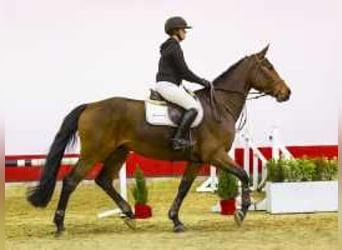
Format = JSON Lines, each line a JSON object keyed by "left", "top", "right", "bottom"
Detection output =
{"left": 95, "top": 147, "right": 134, "bottom": 226}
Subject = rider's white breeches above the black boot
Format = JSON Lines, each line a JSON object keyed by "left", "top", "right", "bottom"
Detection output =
{"left": 155, "top": 81, "right": 199, "bottom": 111}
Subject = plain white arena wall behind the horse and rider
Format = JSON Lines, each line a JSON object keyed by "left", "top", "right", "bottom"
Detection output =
{"left": 0, "top": 0, "right": 342, "bottom": 155}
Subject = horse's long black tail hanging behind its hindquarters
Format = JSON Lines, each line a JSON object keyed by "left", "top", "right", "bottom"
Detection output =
{"left": 27, "top": 104, "right": 87, "bottom": 207}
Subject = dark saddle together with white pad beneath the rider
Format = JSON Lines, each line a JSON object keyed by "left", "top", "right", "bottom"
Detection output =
{"left": 145, "top": 89, "right": 203, "bottom": 127}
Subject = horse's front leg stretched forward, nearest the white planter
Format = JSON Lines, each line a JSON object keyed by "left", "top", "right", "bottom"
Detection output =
{"left": 211, "top": 151, "right": 251, "bottom": 225}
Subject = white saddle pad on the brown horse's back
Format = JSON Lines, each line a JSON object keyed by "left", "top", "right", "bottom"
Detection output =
{"left": 145, "top": 100, "right": 203, "bottom": 128}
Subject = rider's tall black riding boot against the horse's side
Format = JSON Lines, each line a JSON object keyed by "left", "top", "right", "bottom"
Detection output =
{"left": 172, "top": 108, "right": 198, "bottom": 150}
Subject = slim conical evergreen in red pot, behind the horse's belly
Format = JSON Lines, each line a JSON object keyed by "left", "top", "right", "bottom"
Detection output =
{"left": 132, "top": 166, "right": 152, "bottom": 219}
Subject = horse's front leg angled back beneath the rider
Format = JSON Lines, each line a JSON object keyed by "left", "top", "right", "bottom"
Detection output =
{"left": 169, "top": 162, "right": 201, "bottom": 233}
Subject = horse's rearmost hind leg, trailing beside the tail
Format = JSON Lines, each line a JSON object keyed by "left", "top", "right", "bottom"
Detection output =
{"left": 53, "top": 158, "right": 94, "bottom": 236}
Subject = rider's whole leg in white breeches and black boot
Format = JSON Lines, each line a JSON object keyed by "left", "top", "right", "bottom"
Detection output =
{"left": 156, "top": 82, "right": 198, "bottom": 149}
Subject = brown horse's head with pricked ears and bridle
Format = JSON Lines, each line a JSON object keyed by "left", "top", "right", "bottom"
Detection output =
{"left": 248, "top": 45, "right": 291, "bottom": 102}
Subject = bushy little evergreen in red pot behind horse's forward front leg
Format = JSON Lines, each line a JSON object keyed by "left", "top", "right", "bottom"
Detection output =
{"left": 217, "top": 170, "right": 239, "bottom": 215}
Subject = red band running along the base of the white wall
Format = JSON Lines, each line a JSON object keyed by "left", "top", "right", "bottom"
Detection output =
{"left": 5, "top": 145, "right": 338, "bottom": 182}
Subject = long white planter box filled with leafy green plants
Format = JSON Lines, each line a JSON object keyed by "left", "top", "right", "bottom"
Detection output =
{"left": 266, "top": 157, "right": 338, "bottom": 213}
